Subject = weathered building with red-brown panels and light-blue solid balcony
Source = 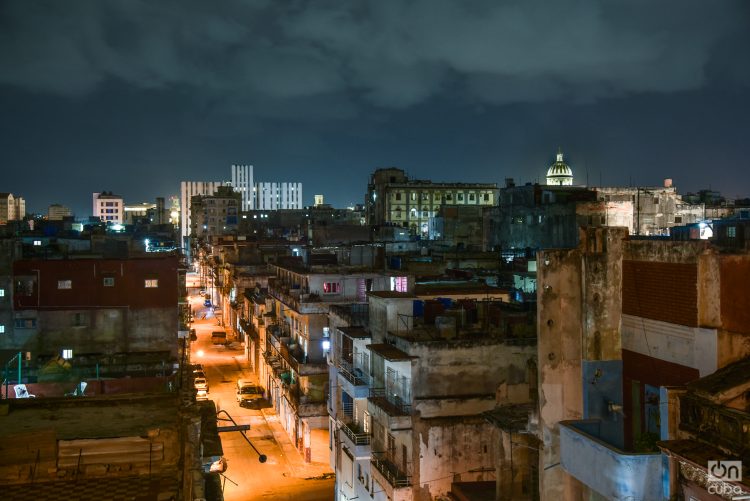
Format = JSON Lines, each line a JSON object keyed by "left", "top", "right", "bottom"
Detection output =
{"left": 537, "top": 228, "right": 750, "bottom": 500}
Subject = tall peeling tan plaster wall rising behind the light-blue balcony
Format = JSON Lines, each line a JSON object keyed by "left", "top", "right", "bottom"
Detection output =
{"left": 537, "top": 228, "right": 627, "bottom": 500}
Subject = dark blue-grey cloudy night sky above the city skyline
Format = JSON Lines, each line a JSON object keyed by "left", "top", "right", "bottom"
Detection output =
{"left": 0, "top": 0, "right": 750, "bottom": 217}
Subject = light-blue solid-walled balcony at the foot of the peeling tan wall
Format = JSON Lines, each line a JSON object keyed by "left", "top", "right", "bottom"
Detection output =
{"left": 560, "top": 419, "right": 662, "bottom": 501}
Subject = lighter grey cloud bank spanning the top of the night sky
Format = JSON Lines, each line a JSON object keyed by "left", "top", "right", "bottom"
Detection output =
{"left": 0, "top": 0, "right": 748, "bottom": 111}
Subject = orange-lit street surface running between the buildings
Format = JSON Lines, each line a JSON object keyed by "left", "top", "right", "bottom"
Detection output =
{"left": 187, "top": 273, "right": 334, "bottom": 501}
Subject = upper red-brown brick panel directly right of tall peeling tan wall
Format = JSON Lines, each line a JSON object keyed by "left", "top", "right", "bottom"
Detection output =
{"left": 622, "top": 261, "right": 698, "bottom": 327}
